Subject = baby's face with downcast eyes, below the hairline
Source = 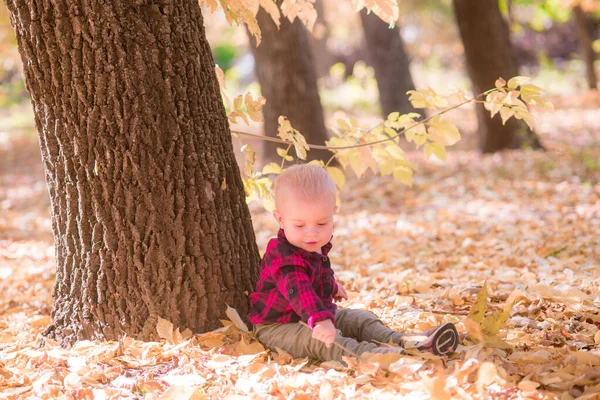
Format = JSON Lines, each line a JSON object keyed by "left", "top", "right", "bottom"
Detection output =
{"left": 273, "top": 196, "right": 336, "bottom": 252}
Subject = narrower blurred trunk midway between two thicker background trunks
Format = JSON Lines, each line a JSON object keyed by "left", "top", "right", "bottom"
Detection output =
{"left": 360, "top": 9, "right": 415, "bottom": 118}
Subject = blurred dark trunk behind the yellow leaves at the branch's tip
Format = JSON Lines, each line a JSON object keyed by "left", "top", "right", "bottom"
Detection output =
{"left": 453, "top": 0, "right": 541, "bottom": 153}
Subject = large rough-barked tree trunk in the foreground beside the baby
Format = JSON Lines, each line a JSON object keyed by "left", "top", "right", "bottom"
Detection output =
{"left": 7, "top": 0, "right": 259, "bottom": 344}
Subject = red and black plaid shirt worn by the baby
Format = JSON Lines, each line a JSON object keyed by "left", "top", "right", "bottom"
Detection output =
{"left": 248, "top": 229, "right": 338, "bottom": 328}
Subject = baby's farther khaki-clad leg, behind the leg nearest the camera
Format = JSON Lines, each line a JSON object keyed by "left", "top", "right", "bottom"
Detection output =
{"left": 335, "top": 308, "right": 404, "bottom": 344}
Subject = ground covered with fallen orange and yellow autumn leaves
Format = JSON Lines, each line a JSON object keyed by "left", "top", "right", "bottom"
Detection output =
{"left": 0, "top": 92, "right": 600, "bottom": 400}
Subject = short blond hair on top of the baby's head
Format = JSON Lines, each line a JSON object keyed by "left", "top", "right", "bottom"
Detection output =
{"left": 273, "top": 164, "right": 336, "bottom": 208}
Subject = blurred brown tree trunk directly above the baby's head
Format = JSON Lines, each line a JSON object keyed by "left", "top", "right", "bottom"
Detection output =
{"left": 249, "top": 1, "right": 332, "bottom": 162}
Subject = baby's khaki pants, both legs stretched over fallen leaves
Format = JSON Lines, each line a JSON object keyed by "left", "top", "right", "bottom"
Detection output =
{"left": 254, "top": 309, "right": 403, "bottom": 362}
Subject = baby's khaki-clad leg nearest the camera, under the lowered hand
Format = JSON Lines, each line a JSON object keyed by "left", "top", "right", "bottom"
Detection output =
{"left": 254, "top": 323, "right": 396, "bottom": 362}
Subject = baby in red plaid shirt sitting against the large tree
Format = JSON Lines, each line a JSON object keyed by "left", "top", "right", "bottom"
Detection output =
{"left": 249, "top": 164, "right": 458, "bottom": 361}
